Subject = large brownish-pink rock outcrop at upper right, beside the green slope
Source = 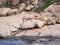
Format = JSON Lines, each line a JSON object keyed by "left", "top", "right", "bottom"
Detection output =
{"left": 44, "top": 4, "right": 60, "bottom": 23}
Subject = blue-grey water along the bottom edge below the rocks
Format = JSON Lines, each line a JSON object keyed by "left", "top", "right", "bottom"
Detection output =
{"left": 0, "top": 39, "right": 60, "bottom": 45}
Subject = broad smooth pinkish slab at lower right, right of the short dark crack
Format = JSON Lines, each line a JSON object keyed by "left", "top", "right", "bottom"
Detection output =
{"left": 40, "top": 24, "right": 60, "bottom": 38}
